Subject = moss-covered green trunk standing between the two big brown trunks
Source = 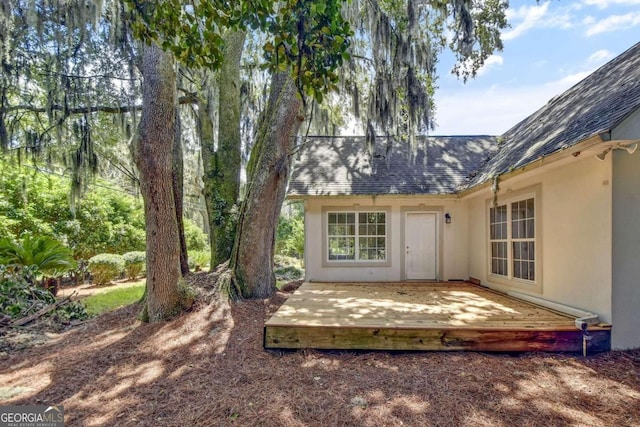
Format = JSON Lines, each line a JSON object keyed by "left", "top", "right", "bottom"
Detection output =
{"left": 200, "top": 31, "right": 245, "bottom": 267}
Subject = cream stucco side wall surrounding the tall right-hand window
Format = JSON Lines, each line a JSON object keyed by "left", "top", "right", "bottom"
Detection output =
{"left": 468, "top": 153, "right": 612, "bottom": 322}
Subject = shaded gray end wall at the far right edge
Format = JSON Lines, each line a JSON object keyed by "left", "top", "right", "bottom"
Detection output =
{"left": 611, "top": 111, "right": 640, "bottom": 349}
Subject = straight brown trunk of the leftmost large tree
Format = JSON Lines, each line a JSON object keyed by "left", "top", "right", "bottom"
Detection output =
{"left": 135, "top": 44, "right": 181, "bottom": 322}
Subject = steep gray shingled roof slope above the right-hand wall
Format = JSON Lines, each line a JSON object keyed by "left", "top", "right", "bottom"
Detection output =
{"left": 467, "top": 43, "right": 640, "bottom": 188}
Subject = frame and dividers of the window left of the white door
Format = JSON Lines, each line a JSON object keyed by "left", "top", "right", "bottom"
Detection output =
{"left": 322, "top": 206, "right": 391, "bottom": 267}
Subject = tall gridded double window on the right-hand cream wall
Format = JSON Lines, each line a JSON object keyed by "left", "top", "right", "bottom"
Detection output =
{"left": 489, "top": 198, "right": 536, "bottom": 282}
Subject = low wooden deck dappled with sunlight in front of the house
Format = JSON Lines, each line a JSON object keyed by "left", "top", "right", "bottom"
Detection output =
{"left": 264, "top": 282, "right": 611, "bottom": 353}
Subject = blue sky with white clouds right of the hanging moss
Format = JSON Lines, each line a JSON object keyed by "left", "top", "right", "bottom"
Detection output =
{"left": 431, "top": 0, "right": 640, "bottom": 135}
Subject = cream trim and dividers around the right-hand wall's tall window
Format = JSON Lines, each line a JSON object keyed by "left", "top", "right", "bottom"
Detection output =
{"left": 485, "top": 185, "right": 542, "bottom": 293}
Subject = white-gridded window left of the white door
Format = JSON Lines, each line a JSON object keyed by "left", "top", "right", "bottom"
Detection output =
{"left": 327, "top": 212, "right": 387, "bottom": 262}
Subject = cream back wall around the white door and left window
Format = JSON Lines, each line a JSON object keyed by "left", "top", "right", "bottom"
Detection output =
{"left": 305, "top": 196, "right": 468, "bottom": 282}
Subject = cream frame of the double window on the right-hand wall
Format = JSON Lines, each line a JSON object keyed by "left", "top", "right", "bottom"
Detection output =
{"left": 485, "top": 185, "right": 542, "bottom": 293}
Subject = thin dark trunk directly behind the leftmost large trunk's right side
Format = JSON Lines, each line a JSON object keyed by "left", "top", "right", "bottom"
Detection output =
{"left": 172, "top": 107, "right": 189, "bottom": 276}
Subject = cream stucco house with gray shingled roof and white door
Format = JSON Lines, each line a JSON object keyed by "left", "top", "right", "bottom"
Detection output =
{"left": 288, "top": 43, "right": 640, "bottom": 349}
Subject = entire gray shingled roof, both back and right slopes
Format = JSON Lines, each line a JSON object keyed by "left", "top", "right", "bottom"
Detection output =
{"left": 289, "top": 43, "right": 640, "bottom": 197}
